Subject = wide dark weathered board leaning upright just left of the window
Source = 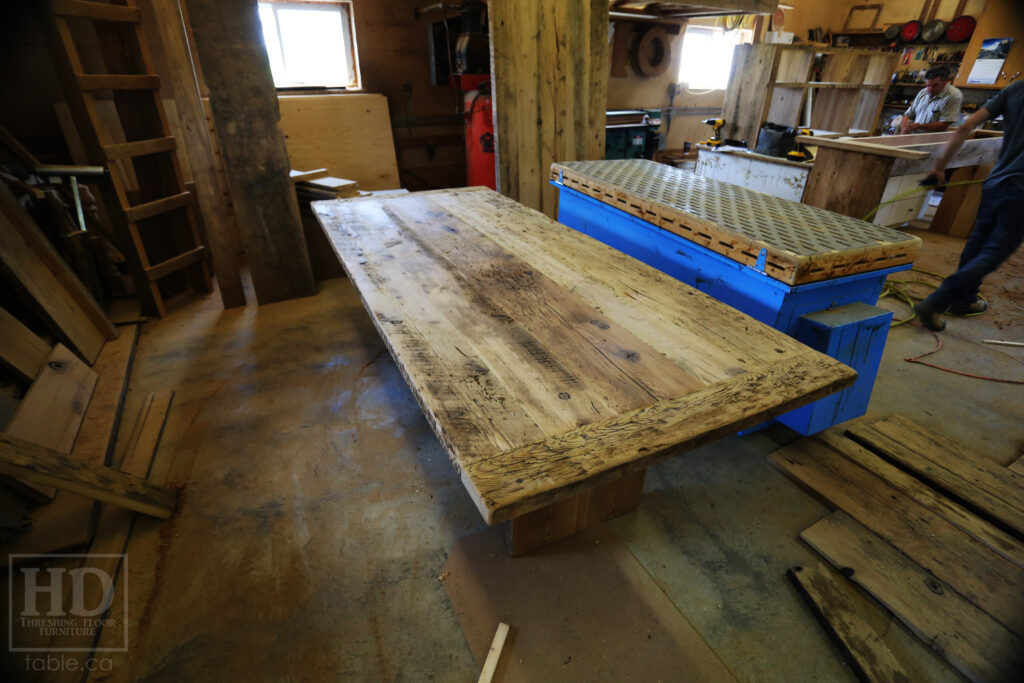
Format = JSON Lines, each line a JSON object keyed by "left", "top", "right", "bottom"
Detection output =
{"left": 187, "top": 0, "right": 316, "bottom": 303}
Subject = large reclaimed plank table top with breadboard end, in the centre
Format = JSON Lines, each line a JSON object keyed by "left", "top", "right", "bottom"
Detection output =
{"left": 312, "top": 187, "right": 856, "bottom": 524}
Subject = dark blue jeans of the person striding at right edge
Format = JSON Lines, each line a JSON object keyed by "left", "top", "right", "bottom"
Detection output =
{"left": 925, "top": 182, "right": 1024, "bottom": 313}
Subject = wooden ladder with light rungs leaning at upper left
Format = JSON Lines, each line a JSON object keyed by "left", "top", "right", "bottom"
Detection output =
{"left": 39, "top": 0, "right": 211, "bottom": 315}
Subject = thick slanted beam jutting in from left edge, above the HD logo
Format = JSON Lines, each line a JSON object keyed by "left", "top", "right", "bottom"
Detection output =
{"left": 0, "top": 434, "right": 176, "bottom": 519}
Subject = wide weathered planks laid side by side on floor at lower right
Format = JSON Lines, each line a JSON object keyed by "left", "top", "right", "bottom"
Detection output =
{"left": 768, "top": 416, "right": 1024, "bottom": 681}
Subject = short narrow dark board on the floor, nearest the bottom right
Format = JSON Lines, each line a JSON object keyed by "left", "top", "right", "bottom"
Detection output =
{"left": 785, "top": 564, "right": 910, "bottom": 683}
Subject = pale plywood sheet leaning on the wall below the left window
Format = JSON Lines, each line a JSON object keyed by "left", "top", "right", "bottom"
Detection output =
{"left": 278, "top": 94, "right": 401, "bottom": 189}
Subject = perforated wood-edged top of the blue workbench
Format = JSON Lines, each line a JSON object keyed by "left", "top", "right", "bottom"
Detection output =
{"left": 551, "top": 159, "right": 921, "bottom": 285}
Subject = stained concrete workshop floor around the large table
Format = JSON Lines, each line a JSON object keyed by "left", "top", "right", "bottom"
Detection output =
{"left": 64, "top": 228, "right": 1024, "bottom": 681}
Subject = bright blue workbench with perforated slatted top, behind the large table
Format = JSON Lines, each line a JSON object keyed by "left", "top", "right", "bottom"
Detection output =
{"left": 551, "top": 159, "right": 921, "bottom": 434}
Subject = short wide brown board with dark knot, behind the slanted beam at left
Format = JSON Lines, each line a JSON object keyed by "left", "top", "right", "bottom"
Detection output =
{"left": 4, "top": 344, "right": 97, "bottom": 502}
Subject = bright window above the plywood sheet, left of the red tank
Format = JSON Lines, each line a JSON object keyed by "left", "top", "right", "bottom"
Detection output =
{"left": 259, "top": 2, "right": 358, "bottom": 88}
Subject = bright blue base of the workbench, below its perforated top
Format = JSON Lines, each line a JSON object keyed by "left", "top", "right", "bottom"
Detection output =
{"left": 551, "top": 180, "right": 911, "bottom": 434}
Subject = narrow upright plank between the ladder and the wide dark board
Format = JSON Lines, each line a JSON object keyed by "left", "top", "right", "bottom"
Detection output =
{"left": 140, "top": 0, "right": 246, "bottom": 308}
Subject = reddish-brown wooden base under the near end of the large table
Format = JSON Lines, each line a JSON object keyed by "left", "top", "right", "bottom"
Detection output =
{"left": 505, "top": 469, "right": 647, "bottom": 557}
